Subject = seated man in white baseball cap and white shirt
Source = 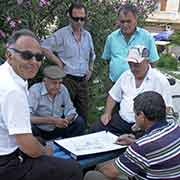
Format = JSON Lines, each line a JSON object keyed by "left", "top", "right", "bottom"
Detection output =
{"left": 90, "top": 46, "right": 172, "bottom": 135}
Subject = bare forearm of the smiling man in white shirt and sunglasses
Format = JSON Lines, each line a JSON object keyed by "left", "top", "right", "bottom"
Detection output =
{"left": 16, "top": 134, "right": 49, "bottom": 158}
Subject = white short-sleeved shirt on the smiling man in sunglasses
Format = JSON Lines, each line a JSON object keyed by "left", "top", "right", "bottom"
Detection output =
{"left": 0, "top": 62, "right": 32, "bottom": 155}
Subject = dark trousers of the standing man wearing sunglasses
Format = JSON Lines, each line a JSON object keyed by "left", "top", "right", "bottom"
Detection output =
{"left": 63, "top": 75, "right": 88, "bottom": 123}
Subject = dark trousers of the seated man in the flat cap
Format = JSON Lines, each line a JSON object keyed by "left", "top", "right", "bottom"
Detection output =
{"left": 32, "top": 116, "right": 85, "bottom": 140}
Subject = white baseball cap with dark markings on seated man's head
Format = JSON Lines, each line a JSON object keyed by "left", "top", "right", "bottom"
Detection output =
{"left": 127, "top": 45, "right": 149, "bottom": 63}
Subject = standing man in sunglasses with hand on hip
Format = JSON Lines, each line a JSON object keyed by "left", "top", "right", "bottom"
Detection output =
{"left": 42, "top": 3, "right": 95, "bottom": 125}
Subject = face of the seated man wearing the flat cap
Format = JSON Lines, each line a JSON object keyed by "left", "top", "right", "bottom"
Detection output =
{"left": 44, "top": 78, "right": 62, "bottom": 97}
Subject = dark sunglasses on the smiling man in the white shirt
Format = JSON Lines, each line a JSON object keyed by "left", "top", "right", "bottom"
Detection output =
{"left": 9, "top": 48, "right": 45, "bottom": 62}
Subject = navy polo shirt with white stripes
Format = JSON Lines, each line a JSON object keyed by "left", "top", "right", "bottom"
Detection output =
{"left": 115, "top": 121, "right": 180, "bottom": 180}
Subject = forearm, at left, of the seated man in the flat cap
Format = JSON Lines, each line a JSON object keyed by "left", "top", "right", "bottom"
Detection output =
{"left": 31, "top": 115, "right": 55, "bottom": 124}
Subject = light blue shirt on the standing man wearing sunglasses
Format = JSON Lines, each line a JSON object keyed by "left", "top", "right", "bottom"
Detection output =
{"left": 42, "top": 25, "right": 96, "bottom": 76}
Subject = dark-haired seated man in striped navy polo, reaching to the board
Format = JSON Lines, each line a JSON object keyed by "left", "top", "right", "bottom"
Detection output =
{"left": 84, "top": 91, "right": 180, "bottom": 180}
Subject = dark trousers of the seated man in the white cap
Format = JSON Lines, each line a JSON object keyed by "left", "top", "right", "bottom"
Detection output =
{"left": 89, "top": 112, "right": 134, "bottom": 136}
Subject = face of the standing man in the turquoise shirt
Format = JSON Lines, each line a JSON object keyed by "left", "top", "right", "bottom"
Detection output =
{"left": 118, "top": 11, "right": 137, "bottom": 36}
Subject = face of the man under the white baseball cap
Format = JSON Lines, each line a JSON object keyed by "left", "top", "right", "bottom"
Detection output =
{"left": 128, "top": 60, "right": 148, "bottom": 79}
